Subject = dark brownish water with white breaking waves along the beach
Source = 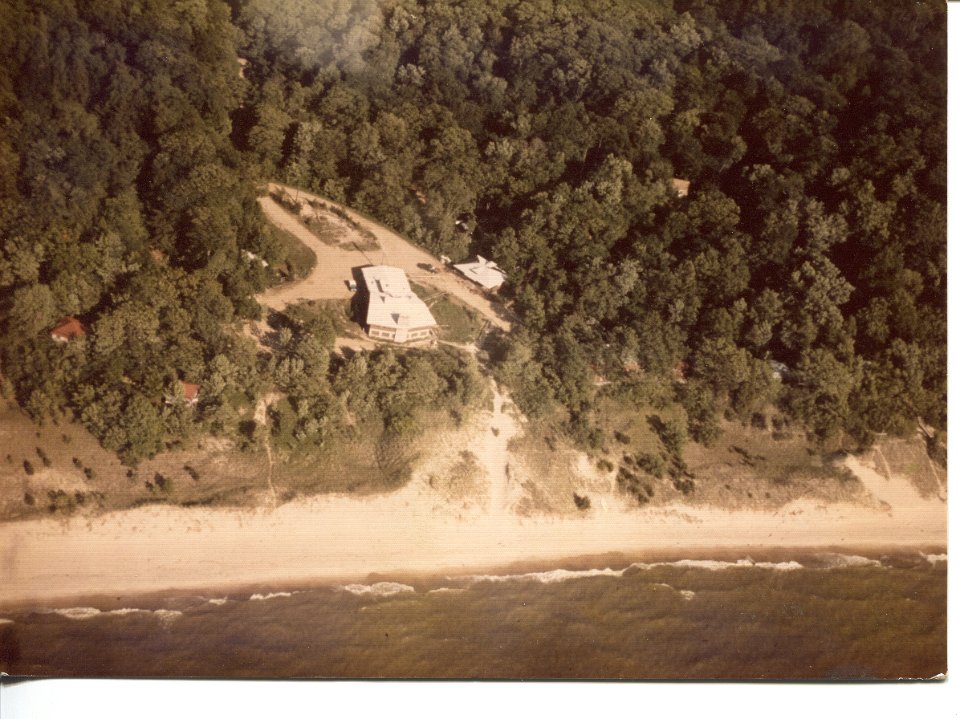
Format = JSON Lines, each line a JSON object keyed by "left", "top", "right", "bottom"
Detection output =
{"left": 0, "top": 552, "right": 947, "bottom": 679}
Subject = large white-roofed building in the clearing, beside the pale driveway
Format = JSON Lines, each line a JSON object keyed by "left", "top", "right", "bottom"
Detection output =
{"left": 360, "top": 265, "right": 437, "bottom": 342}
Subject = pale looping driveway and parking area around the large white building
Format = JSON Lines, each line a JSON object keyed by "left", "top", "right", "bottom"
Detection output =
{"left": 258, "top": 182, "right": 510, "bottom": 331}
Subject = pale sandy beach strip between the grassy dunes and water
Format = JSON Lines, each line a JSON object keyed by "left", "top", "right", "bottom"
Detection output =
{"left": 0, "top": 382, "right": 947, "bottom": 605}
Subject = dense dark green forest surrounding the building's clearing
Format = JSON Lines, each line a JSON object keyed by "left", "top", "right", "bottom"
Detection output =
{"left": 0, "top": 0, "right": 946, "bottom": 458}
